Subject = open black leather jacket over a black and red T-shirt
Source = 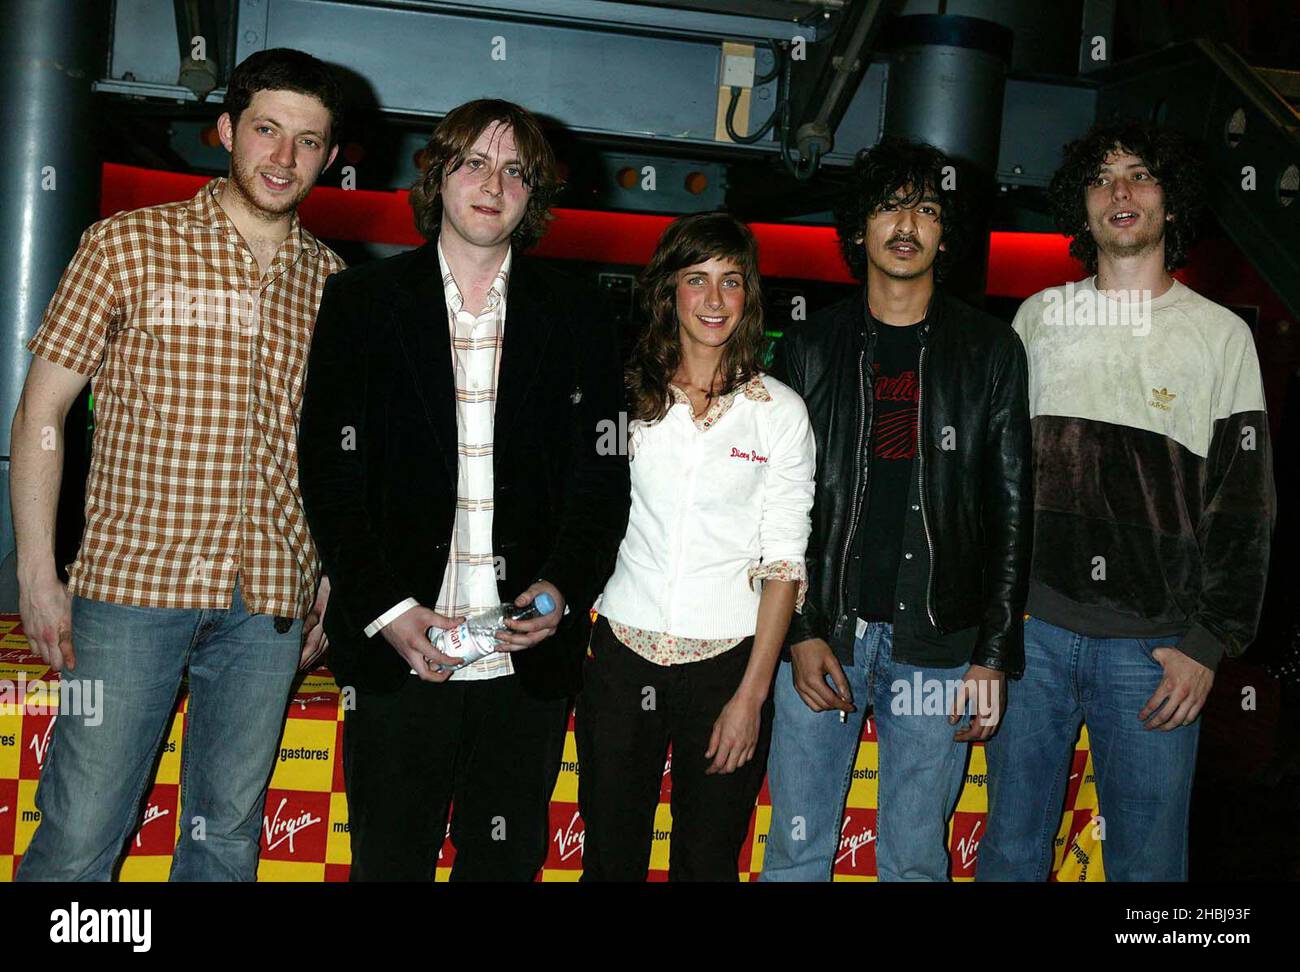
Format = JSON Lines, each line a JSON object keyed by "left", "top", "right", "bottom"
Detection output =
{"left": 774, "top": 288, "right": 1032, "bottom": 677}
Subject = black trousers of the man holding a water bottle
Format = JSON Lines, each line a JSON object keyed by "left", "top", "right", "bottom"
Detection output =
{"left": 343, "top": 676, "right": 568, "bottom": 881}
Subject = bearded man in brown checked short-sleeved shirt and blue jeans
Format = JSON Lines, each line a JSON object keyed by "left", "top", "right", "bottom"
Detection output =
{"left": 12, "top": 48, "right": 342, "bottom": 881}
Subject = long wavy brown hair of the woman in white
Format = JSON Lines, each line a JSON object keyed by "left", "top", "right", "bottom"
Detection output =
{"left": 625, "top": 213, "right": 763, "bottom": 422}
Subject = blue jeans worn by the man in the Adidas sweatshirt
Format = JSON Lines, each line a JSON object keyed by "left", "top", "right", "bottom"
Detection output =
{"left": 976, "top": 617, "right": 1201, "bottom": 881}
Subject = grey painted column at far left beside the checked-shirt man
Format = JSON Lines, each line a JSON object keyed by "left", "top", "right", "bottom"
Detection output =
{"left": 0, "top": 0, "right": 112, "bottom": 576}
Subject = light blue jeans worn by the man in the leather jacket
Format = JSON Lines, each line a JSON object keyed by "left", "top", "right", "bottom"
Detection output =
{"left": 759, "top": 622, "right": 969, "bottom": 881}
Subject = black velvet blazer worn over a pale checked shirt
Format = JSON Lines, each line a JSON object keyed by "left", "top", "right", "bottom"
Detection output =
{"left": 299, "top": 242, "right": 631, "bottom": 698}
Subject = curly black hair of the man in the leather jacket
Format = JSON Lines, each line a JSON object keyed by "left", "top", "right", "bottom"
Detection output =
{"left": 835, "top": 135, "right": 967, "bottom": 281}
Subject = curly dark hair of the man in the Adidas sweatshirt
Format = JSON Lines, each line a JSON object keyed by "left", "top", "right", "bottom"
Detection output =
{"left": 1048, "top": 121, "right": 1205, "bottom": 273}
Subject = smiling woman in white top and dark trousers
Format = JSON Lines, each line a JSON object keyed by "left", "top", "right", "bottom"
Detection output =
{"left": 576, "top": 213, "right": 815, "bottom": 881}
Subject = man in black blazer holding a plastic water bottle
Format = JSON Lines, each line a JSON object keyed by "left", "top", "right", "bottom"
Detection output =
{"left": 299, "top": 100, "right": 631, "bottom": 881}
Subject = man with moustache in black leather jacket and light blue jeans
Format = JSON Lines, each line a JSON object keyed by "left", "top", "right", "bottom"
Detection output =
{"left": 763, "top": 139, "right": 1031, "bottom": 881}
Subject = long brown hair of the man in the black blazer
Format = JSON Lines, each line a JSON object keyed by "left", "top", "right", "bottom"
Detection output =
{"left": 410, "top": 97, "right": 560, "bottom": 249}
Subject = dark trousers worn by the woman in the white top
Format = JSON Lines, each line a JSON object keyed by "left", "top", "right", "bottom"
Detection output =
{"left": 575, "top": 617, "right": 772, "bottom": 881}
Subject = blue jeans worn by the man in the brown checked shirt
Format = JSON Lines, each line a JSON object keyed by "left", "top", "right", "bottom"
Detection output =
{"left": 14, "top": 585, "right": 303, "bottom": 881}
